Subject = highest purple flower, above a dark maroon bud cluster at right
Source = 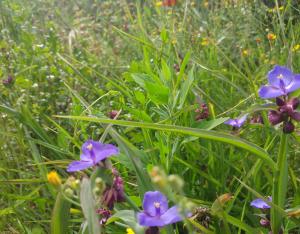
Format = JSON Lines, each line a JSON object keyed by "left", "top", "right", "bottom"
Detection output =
{"left": 258, "top": 65, "right": 300, "bottom": 98}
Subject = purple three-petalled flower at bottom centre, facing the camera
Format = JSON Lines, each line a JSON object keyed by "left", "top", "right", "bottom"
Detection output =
{"left": 138, "top": 191, "right": 182, "bottom": 227}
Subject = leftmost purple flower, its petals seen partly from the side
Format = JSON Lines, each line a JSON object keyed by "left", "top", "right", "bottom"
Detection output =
{"left": 67, "top": 140, "right": 119, "bottom": 172}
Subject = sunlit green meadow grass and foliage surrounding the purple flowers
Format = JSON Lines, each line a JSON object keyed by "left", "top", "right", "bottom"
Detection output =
{"left": 0, "top": 0, "right": 300, "bottom": 233}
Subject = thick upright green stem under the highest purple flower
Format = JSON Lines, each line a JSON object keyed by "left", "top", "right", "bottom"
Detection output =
{"left": 271, "top": 133, "right": 288, "bottom": 234}
